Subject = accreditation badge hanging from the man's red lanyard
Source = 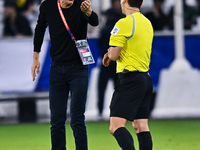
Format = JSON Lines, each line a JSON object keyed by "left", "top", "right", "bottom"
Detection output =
{"left": 75, "top": 39, "right": 95, "bottom": 65}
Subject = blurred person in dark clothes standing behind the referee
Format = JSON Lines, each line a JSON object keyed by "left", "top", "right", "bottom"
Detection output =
{"left": 98, "top": 0, "right": 123, "bottom": 116}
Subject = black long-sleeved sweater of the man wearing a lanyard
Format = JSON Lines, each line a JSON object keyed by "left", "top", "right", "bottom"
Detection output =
{"left": 34, "top": 0, "right": 99, "bottom": 65}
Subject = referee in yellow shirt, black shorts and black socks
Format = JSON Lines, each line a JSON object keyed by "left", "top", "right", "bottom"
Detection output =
{"left": 103, "top": 0, "right": 153, "bottom": 150}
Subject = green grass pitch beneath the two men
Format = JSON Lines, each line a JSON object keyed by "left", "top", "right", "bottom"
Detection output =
{"left": 0, "top": 119, "right": 200, "bottom": 150}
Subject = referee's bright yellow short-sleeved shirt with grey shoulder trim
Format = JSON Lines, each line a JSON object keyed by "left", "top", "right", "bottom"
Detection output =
{"left": 109, "top": 12, "right": 153, "bottom": 73}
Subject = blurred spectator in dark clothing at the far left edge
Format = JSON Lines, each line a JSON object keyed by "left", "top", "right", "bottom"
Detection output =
{"left": 3, "top": 0, "right": 32, "bottom": 37}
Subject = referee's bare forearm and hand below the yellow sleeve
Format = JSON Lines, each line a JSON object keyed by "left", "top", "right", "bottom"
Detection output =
{"left": 103, "top": 46, "right": 122, "bottom": 67}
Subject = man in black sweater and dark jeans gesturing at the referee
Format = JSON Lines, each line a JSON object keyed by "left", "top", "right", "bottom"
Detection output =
{"left": 31, "top": 0, "right": 98, "bottom": 150}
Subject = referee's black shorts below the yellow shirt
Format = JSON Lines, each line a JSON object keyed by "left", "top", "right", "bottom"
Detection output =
{"left": 110, "top": 72, "right": 153, "bottom": 121}
